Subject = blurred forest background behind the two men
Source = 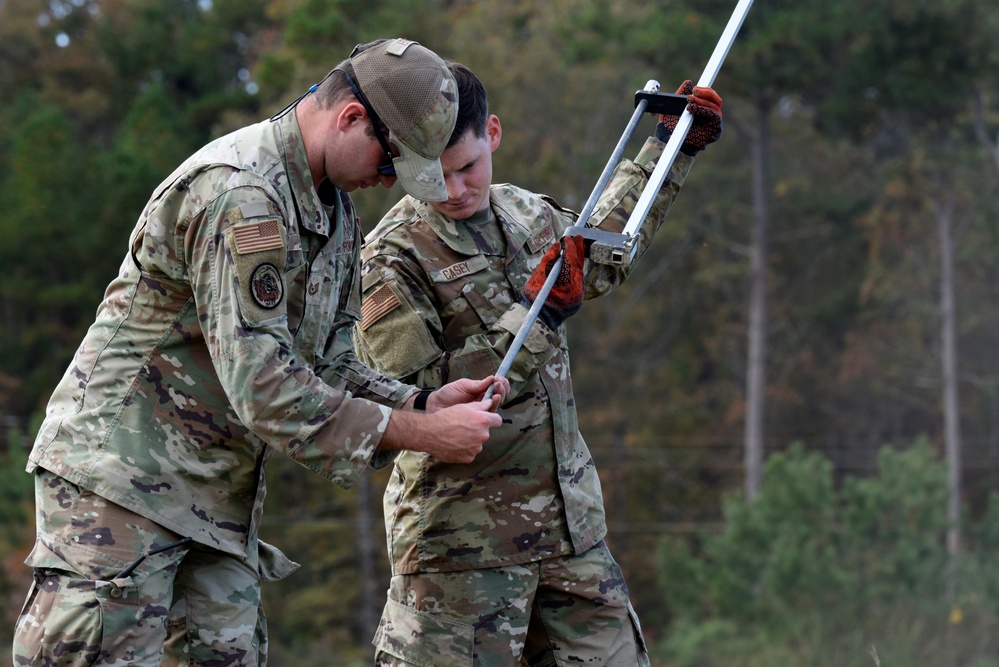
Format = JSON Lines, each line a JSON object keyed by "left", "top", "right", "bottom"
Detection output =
{"left": 0, "top": 0, "right": 999, "bottom": 667}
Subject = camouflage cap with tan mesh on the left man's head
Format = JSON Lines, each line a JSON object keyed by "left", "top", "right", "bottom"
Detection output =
{"left": 350, "top": 39, "right": 458, "bottom": 201}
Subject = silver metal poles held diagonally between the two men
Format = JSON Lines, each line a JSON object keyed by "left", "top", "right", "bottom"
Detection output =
{"left": 486, "top": 0, "right": 753, "bottom": 398}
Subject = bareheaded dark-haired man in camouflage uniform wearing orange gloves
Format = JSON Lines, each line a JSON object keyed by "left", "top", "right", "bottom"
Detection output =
{"left": 357, "top": 63, "right": 721, "bottom": 667}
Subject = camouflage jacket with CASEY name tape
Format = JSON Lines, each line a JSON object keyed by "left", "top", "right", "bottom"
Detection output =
{"left": 357, "top": 139, "right": 693, "bottom": 574}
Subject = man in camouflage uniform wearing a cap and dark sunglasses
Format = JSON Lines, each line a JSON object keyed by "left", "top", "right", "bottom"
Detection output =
{"left": 7, "top": 40, "right": 508, "bottom": 666}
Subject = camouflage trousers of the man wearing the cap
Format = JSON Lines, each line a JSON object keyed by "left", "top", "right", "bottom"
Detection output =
{"left": 14, "top": 471, "right": 267, "bottom": 667}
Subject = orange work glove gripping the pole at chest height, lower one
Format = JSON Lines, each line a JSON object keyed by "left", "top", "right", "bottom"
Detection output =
{"left": 523, "top": 236, "right": 586, "bottom": 330}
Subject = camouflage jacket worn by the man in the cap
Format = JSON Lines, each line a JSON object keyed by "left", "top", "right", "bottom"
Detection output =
{"left": 28, "top": 113, "right": 415, "bottom": 556}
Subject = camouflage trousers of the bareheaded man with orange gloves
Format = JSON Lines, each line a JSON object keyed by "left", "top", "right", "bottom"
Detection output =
{"left": 372, "top": 542, "right": 649, "bottom": 667}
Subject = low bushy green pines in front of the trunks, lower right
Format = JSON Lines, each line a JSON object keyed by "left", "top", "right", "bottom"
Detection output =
{"left": 660, "top": 440, "right": 999, "bottom": 667}
